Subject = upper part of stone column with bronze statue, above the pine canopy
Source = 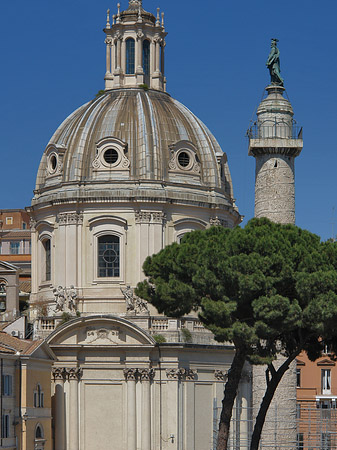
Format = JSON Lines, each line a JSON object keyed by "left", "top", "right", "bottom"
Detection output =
{"left": 248, "top": 39, "right": 303, "bottom": 224}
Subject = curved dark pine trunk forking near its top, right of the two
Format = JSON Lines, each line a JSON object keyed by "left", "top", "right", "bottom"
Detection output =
{"left": 250, "top": 353, "right": 298, "bottom": 450}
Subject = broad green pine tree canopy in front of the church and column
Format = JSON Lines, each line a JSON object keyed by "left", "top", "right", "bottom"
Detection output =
{"left": 136, "top": 219, "right": 337, "bottom": 363}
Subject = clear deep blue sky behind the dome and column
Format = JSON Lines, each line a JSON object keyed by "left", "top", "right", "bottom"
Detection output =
{"left": 0, "top": 0, "right": 337, "bottom": 239}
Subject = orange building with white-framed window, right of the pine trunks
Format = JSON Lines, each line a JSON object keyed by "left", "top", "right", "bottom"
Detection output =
{"left": 297, "top": 352, "right": 337, "bottom": 450}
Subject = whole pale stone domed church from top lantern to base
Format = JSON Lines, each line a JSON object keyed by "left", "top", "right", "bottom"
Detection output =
{"left": 25, "top": 0, "right": 250, "bottom": 450}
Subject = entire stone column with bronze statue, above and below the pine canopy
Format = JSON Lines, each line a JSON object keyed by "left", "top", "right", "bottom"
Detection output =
{"left": 248, "top": 39, "right": 303, "bottom": 448}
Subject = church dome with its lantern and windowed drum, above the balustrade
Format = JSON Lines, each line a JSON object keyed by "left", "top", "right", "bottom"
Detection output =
{"left": 29, "top": 0, "right": 242, "bottom": 322}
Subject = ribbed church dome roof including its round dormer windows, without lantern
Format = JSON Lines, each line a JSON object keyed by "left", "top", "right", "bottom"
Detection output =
{"left": 33, "top": 88, "right": 233, "bottom": 214}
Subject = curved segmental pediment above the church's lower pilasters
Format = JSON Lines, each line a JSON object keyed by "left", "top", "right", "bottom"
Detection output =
{"left": 47, "top": 316, "right": 155, "bottom": 347}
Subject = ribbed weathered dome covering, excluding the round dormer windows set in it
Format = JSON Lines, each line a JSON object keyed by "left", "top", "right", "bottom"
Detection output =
{"left": 36, "top": 89, "right": 232, "bottom": 197}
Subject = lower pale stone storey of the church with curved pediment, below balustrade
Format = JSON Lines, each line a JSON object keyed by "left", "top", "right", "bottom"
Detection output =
{"left": 47, "top": 316, "right": 242, "bottom": 450}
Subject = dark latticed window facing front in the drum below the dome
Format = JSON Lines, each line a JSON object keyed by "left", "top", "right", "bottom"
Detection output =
{"left": 98, "top": 234, "right": 120, "bottom": 277}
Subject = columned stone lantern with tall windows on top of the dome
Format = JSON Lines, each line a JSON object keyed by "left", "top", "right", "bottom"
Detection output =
{"left": 104, "top": 0, "right": 167, "bottom": 91}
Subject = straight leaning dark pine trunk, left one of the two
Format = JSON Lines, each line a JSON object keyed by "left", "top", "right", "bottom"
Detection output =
{"left": 216, "top": 348, "right": 247, "bottom": 450}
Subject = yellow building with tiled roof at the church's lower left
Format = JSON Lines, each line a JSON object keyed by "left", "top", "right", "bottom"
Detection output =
{"left": 0, "top": 331, "right": 55, "bottom": 450}
